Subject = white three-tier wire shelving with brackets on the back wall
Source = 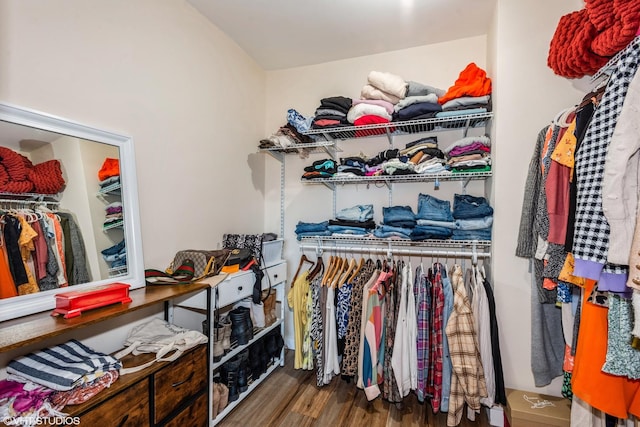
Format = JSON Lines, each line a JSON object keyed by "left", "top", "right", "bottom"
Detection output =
{"left": 260, "top": 112, "right": 493, "bottom": 260}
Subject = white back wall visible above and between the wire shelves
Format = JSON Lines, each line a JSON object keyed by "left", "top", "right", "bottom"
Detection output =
{"left": 265, "top": 36, "right": 487, "bottom": 352}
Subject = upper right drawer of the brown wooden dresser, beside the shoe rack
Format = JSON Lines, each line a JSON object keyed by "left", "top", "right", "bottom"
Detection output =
{"left": 153, "top": 345, "right": 207, "bottom": 423}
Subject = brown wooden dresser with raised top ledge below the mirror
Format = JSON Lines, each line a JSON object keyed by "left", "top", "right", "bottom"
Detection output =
{"left": 0, "top": 284, "right": 210, "bottom": 427}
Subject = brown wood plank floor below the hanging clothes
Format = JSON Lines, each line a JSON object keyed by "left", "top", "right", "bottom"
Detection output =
{"left": 218, "top": 351, "right": 489, "bottom": 427}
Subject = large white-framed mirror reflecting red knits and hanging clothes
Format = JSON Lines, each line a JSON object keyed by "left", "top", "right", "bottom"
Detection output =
{"left": 0, "top": 103, "right": 145, "bottom": 321}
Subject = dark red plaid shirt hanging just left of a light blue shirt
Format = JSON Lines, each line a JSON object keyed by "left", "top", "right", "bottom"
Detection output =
{"left": 429, "top": 264, "right": 444, "bottom": 413}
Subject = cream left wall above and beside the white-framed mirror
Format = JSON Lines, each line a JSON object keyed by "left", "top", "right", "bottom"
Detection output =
{"left": 0, "top": 0, "right": 265, "bottom": 362}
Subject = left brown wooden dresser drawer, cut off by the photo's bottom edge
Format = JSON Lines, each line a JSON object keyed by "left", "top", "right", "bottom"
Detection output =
{"left": 80, "top": 378, "right": 149, "bottom": 427}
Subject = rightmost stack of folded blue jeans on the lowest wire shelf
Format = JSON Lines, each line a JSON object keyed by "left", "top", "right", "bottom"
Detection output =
{"left": 452, "top": 194, "right": 493, "bottom": 240}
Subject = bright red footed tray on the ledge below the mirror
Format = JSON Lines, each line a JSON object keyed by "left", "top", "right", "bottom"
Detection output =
{"left": 51, "top": 283, "right": 131, "bottom": 319}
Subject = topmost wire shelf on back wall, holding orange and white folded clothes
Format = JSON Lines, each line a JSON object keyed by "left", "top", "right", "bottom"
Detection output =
{"left": 304, "top": 112, "right": 493, "bottom": 141}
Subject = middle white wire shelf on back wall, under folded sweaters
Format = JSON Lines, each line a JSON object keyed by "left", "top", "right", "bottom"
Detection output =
{"left": 301, "top": 171, "right": 492, "bottom": 184}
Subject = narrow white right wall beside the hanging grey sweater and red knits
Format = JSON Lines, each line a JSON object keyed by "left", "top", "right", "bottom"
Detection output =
{"left": 490, "top": 0, "right": 583, "bottom": 395}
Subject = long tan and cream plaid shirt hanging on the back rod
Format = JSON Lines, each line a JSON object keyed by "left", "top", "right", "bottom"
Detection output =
{"left": 445, "top": 265, "right": 487, "bottom": 426}
